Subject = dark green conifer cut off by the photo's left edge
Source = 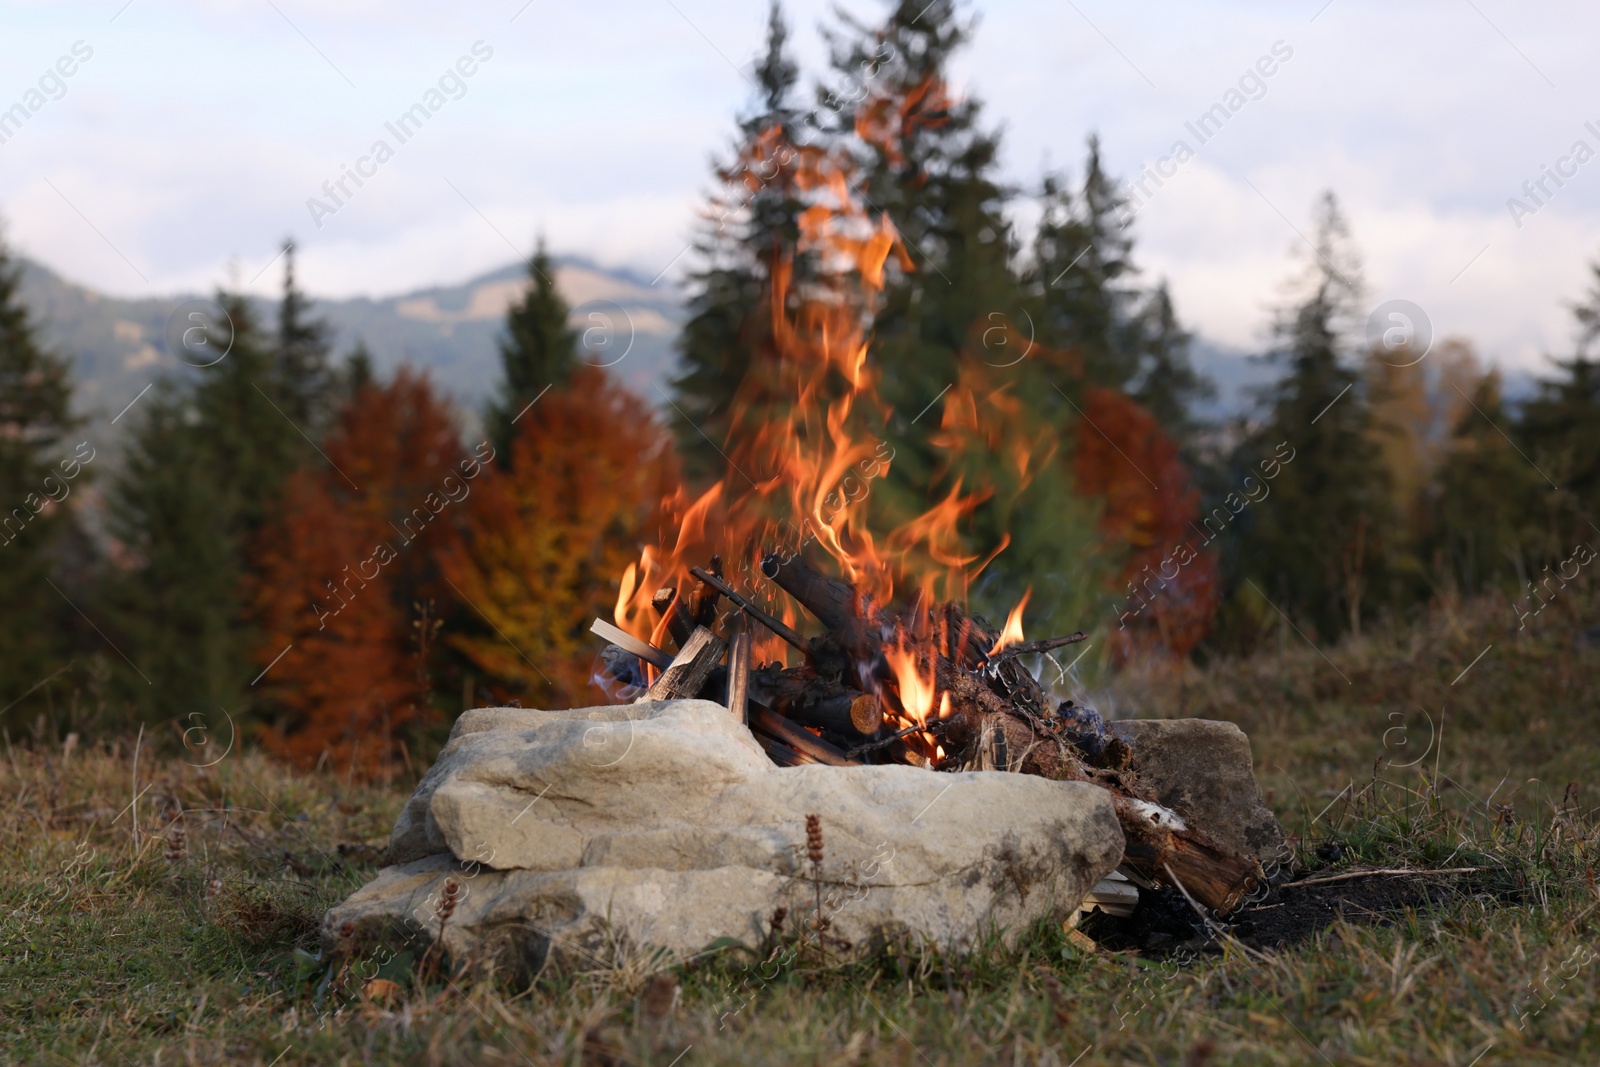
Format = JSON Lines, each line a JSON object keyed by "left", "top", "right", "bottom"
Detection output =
{"left": 0, "top": 230, "right": 82, "bottom": 717}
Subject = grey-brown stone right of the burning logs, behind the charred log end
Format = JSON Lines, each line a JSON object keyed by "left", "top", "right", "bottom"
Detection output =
{"left": 1107, "top": 718, "right": 1288, "bottom": 870}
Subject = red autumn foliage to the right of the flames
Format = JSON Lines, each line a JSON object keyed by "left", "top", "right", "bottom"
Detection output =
{"left": 1074, "top": 386, "right": 1219, "bottom": 661}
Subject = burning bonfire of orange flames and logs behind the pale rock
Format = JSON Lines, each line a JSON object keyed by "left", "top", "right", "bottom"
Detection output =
{"left": 594, "top": 123, "right": 1262, "bottom": 913}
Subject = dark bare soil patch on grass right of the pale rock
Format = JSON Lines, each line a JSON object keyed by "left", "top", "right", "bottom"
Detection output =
{"left": 1080, "top": 872, "right": 1515, "bottom": 957}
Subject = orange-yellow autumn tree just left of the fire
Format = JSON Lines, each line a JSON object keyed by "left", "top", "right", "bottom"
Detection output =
{"left": 440, "top": 366, "right": 678, "bottom": 707}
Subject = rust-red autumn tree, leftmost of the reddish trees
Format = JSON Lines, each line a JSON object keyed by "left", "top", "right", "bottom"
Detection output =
{"left": 254, "top": 368, "right": 482, "bottom": 776}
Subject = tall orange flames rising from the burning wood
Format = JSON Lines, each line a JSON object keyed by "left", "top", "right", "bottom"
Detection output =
{"left": 616, "top": 116, "right": 1053, "bottom": 694}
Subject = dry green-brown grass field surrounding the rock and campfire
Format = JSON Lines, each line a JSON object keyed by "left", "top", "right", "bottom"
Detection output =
{"left": 0, "top": 597, "right": 1600, "bottom": 1067}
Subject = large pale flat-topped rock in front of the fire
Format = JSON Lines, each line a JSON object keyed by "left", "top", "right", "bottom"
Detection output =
{"left": 323, "top": 701, "right": 1123, "bottom": 973}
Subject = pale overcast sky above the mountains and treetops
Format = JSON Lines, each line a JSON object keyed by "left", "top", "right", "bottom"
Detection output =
{"left": 0, "top": 0, "right": 1600, "bottom": 366}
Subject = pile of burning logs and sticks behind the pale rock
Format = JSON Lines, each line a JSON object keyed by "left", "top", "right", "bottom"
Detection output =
{"left": 594, "top": 553, "right": 1264, "bottom": 915}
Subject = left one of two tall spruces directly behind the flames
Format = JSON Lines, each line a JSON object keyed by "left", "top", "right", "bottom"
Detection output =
{"left": 672, "top": 0, "right": 821, "bottom": 480}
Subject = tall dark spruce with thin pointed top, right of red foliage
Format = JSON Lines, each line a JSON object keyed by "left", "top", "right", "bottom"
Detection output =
{"left": 1224, "top": 194, "right": 1392, "bottom": 637}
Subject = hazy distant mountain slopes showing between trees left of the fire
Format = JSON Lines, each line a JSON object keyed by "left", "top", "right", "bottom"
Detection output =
{"left": 21, "top": 256, "right": 683, "bottom": 418}
